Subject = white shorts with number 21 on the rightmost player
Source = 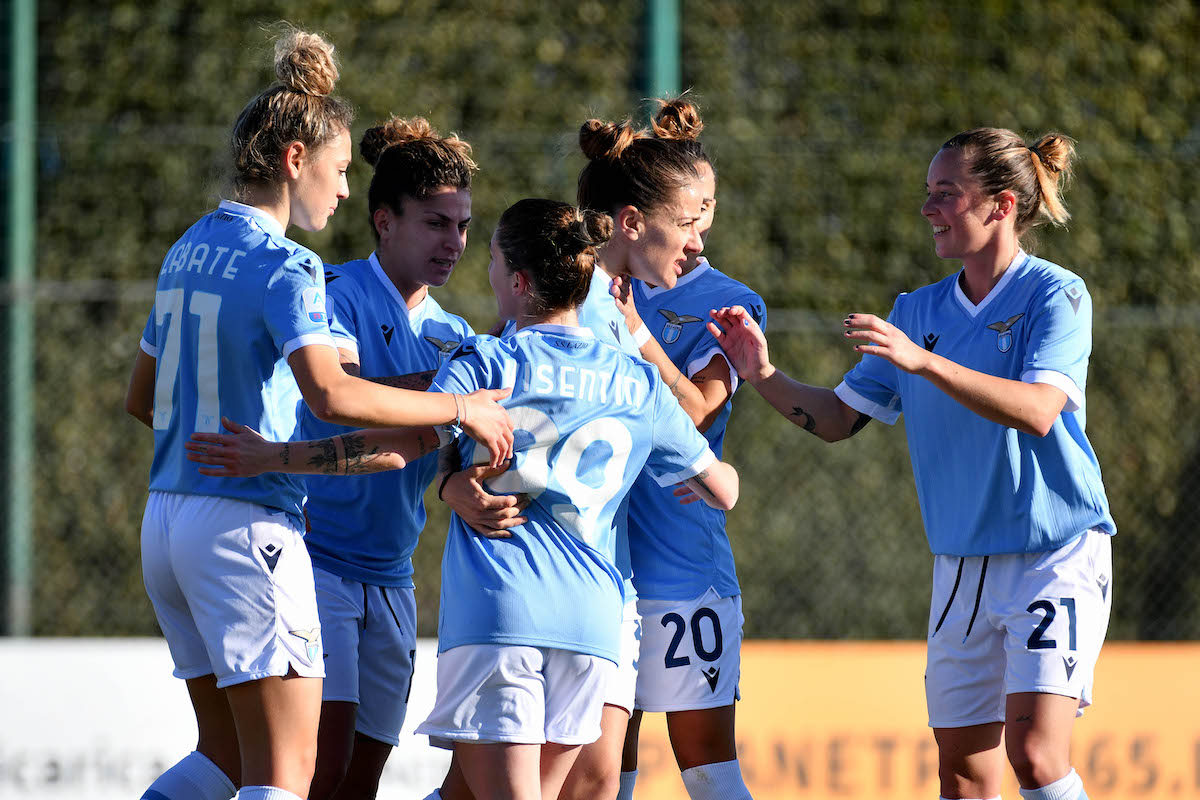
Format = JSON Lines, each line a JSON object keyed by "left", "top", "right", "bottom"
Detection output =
{"left": 925, "top": 530, "right": 1112, "bottom": 728}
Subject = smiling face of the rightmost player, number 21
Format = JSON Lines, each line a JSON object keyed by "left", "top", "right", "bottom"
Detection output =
{"left": 920, "top": 150, "right": 1001, "bottom": 260}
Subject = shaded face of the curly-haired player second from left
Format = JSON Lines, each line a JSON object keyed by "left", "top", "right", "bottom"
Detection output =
{"left": 374, "top": 186, "right": 470, "bottom": 297}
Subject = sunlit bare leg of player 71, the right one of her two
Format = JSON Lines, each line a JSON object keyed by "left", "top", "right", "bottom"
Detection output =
{"left": 226, "top": 673, "right": 320, "bottom": 798}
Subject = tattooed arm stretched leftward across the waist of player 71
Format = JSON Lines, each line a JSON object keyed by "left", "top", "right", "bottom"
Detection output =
{"left": 184, "top": 417, "right": 438, "bottom": 477}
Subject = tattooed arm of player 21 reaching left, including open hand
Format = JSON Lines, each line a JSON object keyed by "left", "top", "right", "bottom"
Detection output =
{"left": 708, "top": 306, "right": 871, "bottom": 441}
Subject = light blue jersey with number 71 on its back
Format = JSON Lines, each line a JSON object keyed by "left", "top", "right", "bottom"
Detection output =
{"left": 142, "top": 200, "right": 334, "bottom": 530}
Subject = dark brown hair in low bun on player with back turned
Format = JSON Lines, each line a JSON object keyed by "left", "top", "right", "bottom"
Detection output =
{"left": 496, "top": 198, "right": 612, "bottom": 315}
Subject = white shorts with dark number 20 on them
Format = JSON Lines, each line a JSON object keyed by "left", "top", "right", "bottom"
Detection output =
{"left": 636, "top": 589, "right": 744, "bottom": 711}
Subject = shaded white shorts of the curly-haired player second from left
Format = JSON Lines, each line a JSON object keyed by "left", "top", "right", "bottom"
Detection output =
{"left": 313, "top": 567, "right": 416, "bottom": 747}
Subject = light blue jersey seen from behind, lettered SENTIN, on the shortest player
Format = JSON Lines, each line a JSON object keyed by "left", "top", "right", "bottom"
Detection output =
{"left": 433, "top": 325, "right": 714, "bottom": 662}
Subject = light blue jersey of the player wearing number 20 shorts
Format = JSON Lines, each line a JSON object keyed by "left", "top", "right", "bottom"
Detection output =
{"left": 629, "top": 258, "right": 767, "bottom": 600}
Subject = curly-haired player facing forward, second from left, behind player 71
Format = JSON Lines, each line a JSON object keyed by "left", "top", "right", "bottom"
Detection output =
{"left": 299, "top": 118, "right": 475, "bottom": 800}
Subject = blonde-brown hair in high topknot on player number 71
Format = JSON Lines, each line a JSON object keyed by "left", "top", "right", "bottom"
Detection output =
{"left": 232, "top": 28, "right": 354, "bottom": 197}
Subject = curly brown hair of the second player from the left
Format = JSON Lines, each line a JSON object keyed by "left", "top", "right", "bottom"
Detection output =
{"left": 359, "top": 116, "right": 479, "bottom": 239}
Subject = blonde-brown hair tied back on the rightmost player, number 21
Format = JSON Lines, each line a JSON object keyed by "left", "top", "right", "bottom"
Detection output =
{"left": 942, "top": 128, "right": 1075, "bottom": 236}
